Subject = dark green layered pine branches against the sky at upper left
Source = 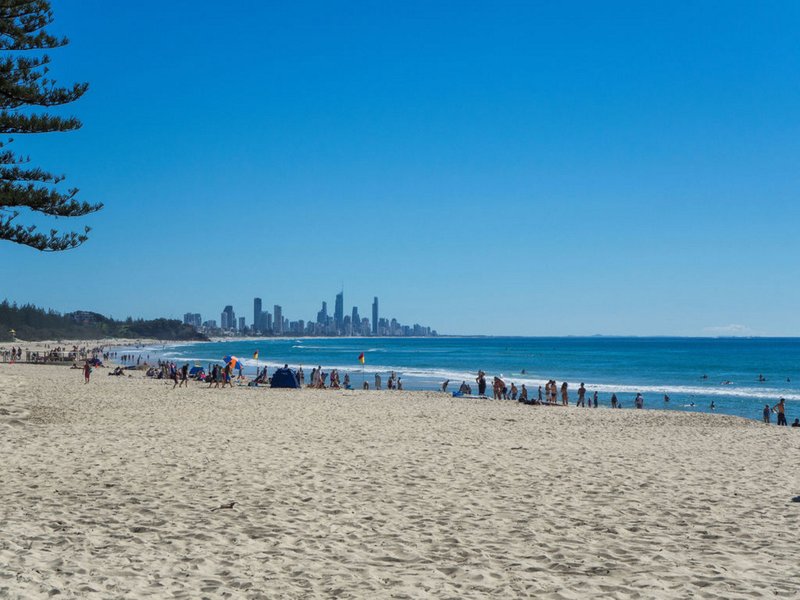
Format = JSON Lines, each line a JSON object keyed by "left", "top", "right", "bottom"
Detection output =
{"left": 0, "top": 0, "right": 103, "bottom": 252}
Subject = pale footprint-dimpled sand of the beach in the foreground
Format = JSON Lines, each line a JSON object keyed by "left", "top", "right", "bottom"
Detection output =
{"left": 0, "top": 364, "right": 800, "bottom": 599}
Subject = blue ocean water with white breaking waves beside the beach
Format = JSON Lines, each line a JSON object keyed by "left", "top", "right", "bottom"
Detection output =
{"left": 120, "top": 337, "right": 800, "bottom": 420}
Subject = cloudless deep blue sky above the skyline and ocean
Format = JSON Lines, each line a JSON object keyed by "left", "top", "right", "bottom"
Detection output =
{"left": 0, "top": 0, "right": 800, "bottom": 335}
